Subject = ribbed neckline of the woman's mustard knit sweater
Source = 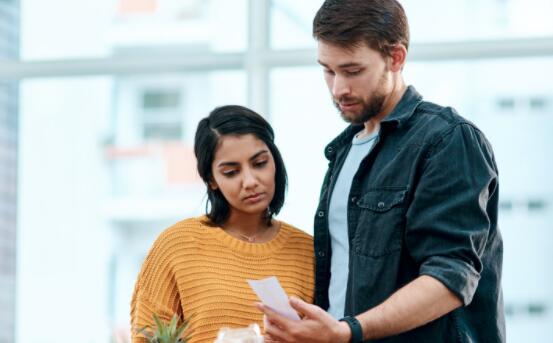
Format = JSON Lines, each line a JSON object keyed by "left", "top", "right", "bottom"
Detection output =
{"left": 198, "top": 216, "right": 291, "bottom": 257}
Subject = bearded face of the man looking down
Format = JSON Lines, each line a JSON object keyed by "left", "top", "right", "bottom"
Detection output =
{"left": 318, "top": 41, "right": 392, "bottom": 124}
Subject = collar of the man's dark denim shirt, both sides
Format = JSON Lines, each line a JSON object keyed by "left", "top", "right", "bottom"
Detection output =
{"left": 325, "top": 86, "right": 422, "bottom": 160}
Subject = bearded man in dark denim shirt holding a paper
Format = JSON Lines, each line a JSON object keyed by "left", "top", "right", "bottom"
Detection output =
{"left": 258, "top": 0, "right": 505, "bottom": 342}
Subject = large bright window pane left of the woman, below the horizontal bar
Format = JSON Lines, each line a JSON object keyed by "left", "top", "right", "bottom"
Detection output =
{"left": 16, "top": 71, "right": 245, "bottom": 343}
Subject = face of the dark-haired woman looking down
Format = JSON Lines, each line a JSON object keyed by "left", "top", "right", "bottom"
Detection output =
{"left": 209, "top": 134, "right": 276, "bottom": 215}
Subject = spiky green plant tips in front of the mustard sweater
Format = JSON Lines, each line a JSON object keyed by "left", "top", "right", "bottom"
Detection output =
{"left": 138, "top": 314, "right": 190, "bottom": 343}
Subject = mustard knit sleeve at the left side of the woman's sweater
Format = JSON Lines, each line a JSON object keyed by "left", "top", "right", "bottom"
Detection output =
{"left": 131, "top": 234, "right": 182, "bottom": 343}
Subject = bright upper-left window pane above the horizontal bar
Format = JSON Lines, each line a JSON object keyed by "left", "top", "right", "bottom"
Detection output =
{"left": 21, "top": 0, "right": 247, "bottom": 60}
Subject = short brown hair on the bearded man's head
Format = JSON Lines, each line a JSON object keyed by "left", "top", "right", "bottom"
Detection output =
{"left": 313, "top": 0, "right": 409, "bottom": 57}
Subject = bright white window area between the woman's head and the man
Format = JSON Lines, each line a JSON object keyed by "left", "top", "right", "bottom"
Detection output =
{"left": 270, "top": 67, "right": 346, "bottom": 234}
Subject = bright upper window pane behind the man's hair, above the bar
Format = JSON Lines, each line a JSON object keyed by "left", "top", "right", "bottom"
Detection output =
{"left": 271, "top": 0, "right": 553, "bottom": 49}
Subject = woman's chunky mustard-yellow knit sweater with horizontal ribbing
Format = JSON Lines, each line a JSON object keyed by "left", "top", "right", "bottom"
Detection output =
{"left": 127, "top": 217, "right": 314, "bottom": 343}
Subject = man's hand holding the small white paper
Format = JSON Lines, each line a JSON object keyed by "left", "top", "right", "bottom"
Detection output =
{"left": 257, "top": 297, "right": 351, "bottom": 343}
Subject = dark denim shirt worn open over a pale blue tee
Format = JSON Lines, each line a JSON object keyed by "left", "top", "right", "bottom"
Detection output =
{"left": 315, "top": 87, "right": 505, "bottom": 342}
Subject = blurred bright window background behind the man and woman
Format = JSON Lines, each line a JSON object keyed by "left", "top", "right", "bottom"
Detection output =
{"left": 0, "top": 0, "right": 553, "bottom": 343}
